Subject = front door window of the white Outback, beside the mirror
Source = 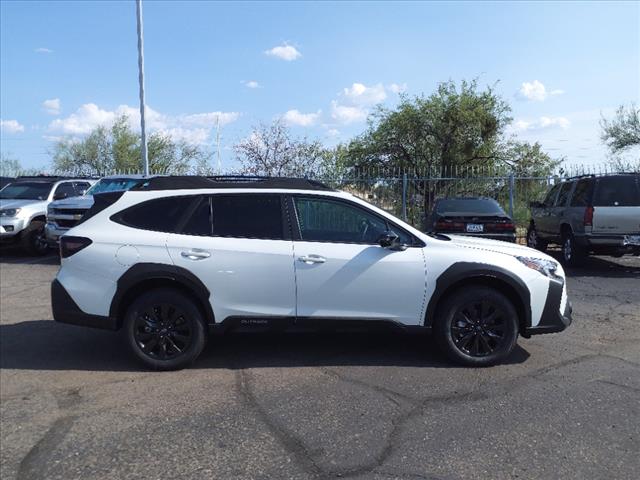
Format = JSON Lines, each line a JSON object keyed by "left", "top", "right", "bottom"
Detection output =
{"left": 294, "top": 197, "right": 387, "bottom": 244}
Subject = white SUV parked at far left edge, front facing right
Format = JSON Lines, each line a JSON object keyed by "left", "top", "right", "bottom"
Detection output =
{"left": 0, "top": 176, "right": 95, "bottom": 255}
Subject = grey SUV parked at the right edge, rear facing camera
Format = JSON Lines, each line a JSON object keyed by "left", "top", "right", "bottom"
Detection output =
{"left": 527, "top": 174, "right": 640, "bottom": 266}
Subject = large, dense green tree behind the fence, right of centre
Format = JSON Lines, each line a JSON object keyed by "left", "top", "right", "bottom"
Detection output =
{"left": 342, "top": 80, "right": 511, "bottom": 176}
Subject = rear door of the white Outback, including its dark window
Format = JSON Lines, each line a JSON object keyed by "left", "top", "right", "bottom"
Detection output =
{"left": 167, "top": 193, "right": 295, "bottom": 322}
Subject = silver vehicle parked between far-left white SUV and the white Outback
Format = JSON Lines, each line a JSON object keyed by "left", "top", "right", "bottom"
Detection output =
{"left": 45, "top": 175, "right": 148, "bottom": 246}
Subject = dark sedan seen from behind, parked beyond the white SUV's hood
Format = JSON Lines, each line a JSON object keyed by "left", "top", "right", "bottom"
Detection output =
{"left": 425, "top": 197, "right": 516, "bottom": 242}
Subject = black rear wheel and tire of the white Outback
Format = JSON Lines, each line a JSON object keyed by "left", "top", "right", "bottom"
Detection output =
{"left": 124, "top": 288, "right": 206, "bottom": 370}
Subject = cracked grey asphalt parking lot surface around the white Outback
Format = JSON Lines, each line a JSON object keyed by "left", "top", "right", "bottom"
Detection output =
{"left": 0, "top": 252, "right": 640, "bottom": 479}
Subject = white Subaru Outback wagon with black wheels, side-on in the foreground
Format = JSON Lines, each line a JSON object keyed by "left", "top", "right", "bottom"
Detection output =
{"left": 52, "top": 177, "right": 571, "bottom": 370}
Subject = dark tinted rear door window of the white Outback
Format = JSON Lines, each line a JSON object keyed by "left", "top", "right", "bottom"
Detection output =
{"left": 212, "top": 194, "right": 284, "bottom": 240}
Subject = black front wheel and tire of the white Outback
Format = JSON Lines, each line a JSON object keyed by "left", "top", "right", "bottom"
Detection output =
{"left": 434, "top": 286, "right": 518, "bottom": 367}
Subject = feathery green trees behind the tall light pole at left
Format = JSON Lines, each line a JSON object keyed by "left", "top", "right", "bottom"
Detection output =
{"left": 53, "top": 115, "right": 209, "bottom": 175}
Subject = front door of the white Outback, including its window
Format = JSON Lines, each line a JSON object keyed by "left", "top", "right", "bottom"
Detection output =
{"left": 292, "top": 196, "right": 425, "bottom": 325}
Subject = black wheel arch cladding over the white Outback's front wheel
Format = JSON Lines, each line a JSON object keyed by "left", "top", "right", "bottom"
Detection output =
{"left": 424, "top": 262, "right": 531, "bottom": 330}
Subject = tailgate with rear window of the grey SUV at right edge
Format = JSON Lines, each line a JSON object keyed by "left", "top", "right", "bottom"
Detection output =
{"left": 592, "top": 175, "right": 640, "bottom": 235}
